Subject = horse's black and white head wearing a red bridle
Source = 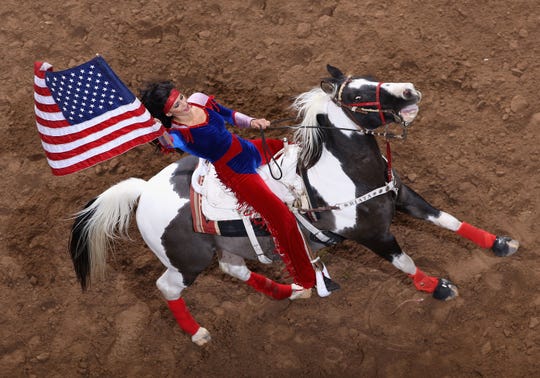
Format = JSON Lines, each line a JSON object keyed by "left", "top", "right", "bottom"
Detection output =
{"left": 321, "top": 65, "right": 422, "bottom": 130}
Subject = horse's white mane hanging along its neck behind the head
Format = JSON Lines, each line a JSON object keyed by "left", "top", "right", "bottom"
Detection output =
{"left": 291, "top": 88, "right": 331, "bottom": 166}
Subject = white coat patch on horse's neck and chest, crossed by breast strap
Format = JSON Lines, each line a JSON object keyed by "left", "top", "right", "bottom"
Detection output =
{"left": 308, "top": 148, "right": 356, "bottom": 233}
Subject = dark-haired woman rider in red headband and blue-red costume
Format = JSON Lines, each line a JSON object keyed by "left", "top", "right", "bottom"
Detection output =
{"left": 139, "top": 81, "right": 315, "bottom": 334}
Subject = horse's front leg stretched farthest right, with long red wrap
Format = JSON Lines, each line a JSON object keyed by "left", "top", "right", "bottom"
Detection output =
{"left": 397, "top": 185, "right": 519, "bottom": 257}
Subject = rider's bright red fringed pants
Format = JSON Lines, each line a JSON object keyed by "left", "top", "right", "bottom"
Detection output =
{"left": 214, "top": 140, "right": 315, "bottom": 288}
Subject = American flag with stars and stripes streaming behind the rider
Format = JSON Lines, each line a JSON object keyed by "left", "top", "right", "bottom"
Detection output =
{"left": 34, "top": 56, "right": 163, "bottom": 176}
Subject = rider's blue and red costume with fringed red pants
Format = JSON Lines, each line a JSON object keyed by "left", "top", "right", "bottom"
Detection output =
{"left": 160, "top": 93, "right": 315, "bottom": 288}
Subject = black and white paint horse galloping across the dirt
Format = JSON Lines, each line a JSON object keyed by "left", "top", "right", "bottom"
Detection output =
{"left": 70, "top": 66, "right": 519, "bottom": 345}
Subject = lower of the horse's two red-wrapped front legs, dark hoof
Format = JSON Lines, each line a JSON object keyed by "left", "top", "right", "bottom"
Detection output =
{"left": 361, "top": 233, "right": 459, "bottom": 301}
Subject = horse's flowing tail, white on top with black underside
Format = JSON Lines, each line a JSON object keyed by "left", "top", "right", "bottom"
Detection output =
{"left": 69, "top": 178, "right": 148, "bottom": 291}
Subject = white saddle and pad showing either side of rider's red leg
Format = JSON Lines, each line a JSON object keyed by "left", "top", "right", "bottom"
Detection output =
{"left": 191, "top": 144, "right": 304, "bottom": 221}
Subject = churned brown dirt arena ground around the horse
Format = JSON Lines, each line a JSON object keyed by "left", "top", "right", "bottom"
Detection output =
{"left": 0, "top": 0, "right": 540, "bottom": 377}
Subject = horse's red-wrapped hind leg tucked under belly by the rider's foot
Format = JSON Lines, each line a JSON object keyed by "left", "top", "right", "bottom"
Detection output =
{"left": 219, "top": 251, "right": 311, "bottom": 300}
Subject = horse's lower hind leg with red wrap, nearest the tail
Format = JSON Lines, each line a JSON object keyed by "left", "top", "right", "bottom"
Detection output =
{"left": 156, "top": 268, "right": 211, "bottom": 346}
